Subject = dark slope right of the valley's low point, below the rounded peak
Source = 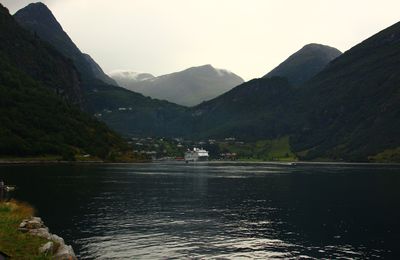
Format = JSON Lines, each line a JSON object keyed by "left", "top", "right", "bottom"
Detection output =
{"left": 185, "top": 77, "right": 294, "bottom": 140}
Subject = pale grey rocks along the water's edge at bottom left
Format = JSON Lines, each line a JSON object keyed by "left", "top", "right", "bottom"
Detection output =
{"left": 18, "top": 217, "right": 77, "bottom": 260}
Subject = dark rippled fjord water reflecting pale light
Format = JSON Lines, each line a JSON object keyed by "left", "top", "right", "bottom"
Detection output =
{"left": 0, "top": 162, "right": 400, "bottom": 259}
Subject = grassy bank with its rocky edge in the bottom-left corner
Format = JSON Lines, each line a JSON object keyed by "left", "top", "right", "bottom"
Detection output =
{"left": 0, "top": 200, "right": 76, "bottom": 259}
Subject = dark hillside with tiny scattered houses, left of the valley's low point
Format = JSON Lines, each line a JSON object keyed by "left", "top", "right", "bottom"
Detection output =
{"left": 85, "top": 83, "right": 186, "bottom": 137}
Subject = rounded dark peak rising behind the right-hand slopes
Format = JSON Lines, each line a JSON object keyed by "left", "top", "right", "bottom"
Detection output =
{"left": 264, "top": 43, "right": 342, "bottom": 86}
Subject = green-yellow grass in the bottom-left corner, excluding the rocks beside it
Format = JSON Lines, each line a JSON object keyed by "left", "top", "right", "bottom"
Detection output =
{"left": 0, "top": 201, "right": 51, "bottom": 259}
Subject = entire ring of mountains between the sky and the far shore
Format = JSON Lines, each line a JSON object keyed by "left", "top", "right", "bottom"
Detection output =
{"left": 0, "top": 3, "right": 400, "bottom": 162}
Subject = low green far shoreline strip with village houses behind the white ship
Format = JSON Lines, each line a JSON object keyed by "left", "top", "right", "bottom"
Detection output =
{"left": 0, "top": 136, "right": 400, "bottom": 164}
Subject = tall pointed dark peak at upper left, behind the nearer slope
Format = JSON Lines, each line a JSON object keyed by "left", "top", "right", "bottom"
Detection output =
{"left": 14, "top": 2, "right": 116, "bottom": 84}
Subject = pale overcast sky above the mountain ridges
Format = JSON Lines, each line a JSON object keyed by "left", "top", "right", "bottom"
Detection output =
{"left": 0, "top": 0, "right": 400, "bottom": 80}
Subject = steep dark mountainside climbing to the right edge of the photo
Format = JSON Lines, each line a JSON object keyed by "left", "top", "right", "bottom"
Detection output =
{"left": 293, "top": 23, "right": 400, "bottom": 161}
